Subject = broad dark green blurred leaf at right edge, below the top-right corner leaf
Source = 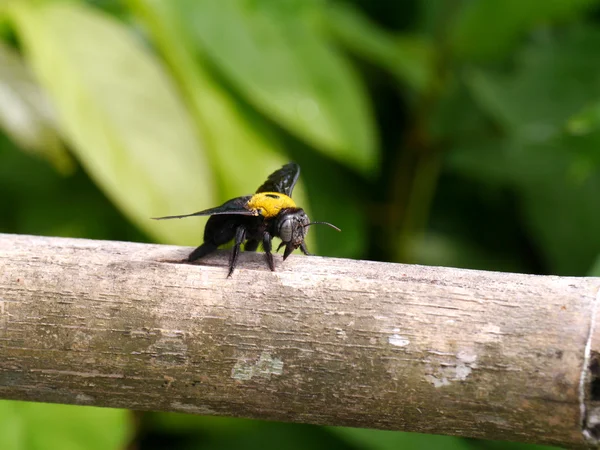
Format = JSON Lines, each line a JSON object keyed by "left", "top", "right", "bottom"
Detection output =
{"left": 465, "top": 28, "right": 600, "bottom": 142}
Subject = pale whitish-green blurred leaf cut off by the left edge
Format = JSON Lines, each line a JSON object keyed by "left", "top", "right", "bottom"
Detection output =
{"left": 0, "top": 41, "right": 73, "bottom": 173}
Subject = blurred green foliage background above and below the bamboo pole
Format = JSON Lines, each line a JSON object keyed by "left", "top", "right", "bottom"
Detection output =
{"left": 0, "top": 0, "right": 600, "bottom": 450}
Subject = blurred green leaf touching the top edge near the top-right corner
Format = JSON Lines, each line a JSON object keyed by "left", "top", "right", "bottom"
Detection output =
{"left": 450, "top": 0, "right": 597, "bottom": 60}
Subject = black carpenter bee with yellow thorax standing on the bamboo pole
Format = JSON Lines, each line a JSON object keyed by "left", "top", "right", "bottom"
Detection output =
{"left": 153, "top": 163, "right": 341, "bottom": 278}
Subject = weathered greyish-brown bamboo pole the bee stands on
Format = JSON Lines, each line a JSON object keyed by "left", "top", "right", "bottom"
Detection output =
{"left": 0, "top": 235, "right": 600, "bottom": 447}
